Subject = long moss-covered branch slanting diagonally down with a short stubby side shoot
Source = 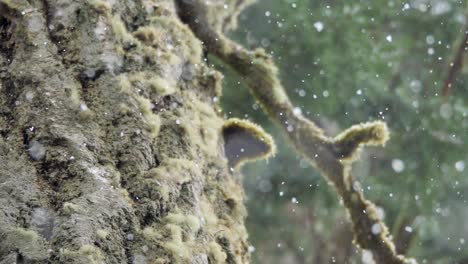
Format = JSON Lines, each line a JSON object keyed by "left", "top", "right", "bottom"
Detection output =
{"left": 177, "top": 0, "right": 416, "bottom": 264}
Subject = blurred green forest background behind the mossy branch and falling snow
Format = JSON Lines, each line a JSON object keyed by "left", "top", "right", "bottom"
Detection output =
{"left": 216, "top": 0, "right": 468, "bottom": 264}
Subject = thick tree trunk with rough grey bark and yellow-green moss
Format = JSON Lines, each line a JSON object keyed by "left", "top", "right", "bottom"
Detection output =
{"left": 0, "top": 0, "right": 249, "bottom": 264}
